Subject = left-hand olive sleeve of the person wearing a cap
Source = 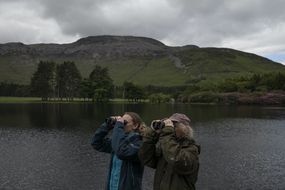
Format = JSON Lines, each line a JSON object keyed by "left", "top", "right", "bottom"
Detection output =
{"left": 139, "top": 127, "right": 158, "bottom": 168}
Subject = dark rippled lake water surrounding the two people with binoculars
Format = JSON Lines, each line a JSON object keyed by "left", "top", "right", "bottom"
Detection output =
{"left": 0, "top": 104, "right": 285, "bottom": 190}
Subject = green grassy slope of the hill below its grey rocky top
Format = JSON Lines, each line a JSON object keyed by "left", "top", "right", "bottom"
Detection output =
{"left": 0, "top": 48, "right": 285, "bottom": 86}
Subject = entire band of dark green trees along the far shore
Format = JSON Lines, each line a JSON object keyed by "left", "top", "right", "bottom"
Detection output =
{"left": 0, "top": 61, "right": 285, "bottom": 103}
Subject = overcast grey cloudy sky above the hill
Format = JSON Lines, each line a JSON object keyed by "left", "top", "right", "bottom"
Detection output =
{"left": 0, "top": 0, "right": 285, "bottom": 64}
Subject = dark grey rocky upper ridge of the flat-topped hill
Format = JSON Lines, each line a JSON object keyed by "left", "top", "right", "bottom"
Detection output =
{"left": 0, "top": 36, "right": 170, "bottom": 59}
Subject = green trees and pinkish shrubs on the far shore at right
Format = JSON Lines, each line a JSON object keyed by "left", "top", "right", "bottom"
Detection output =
{"left": 176, "top": 72, "right": 285, "bottom": 104}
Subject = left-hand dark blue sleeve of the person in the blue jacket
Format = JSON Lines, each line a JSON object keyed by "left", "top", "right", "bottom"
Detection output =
{"left": 91, "top": 123, "right": 112, "bottom": 153}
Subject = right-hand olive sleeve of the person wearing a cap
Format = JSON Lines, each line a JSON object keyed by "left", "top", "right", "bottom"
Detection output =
{"left": 160, "top": 127, "right": 199, "bottom": 175}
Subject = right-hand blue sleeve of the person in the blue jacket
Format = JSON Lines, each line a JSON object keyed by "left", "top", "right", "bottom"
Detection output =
{"left": 112, "top": 122, "right": 142, "bottom": 161}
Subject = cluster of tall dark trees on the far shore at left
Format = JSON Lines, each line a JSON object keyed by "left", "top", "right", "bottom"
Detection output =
{"left": 30, "top": 61, "right": 113, "bottom": 101}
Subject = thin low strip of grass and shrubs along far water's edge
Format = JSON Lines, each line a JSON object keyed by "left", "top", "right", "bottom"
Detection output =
{"left": 0, "top": 91, "right": 285, "bottom": 107}
